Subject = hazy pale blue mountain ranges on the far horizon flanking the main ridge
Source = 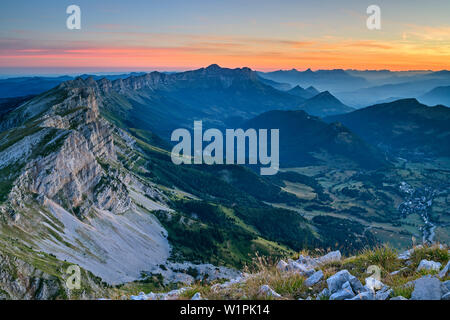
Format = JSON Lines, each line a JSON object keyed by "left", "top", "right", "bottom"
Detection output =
{"left": 0, "top": 69, "right": 450, "bottom": 108}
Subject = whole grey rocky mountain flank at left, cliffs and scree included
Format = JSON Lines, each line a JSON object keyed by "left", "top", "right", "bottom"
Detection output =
{"left": 0, "top": 79, "right": 174, "bottom": 292}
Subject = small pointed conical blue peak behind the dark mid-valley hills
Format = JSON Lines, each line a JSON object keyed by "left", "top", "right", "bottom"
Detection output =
{"left": 300, "top": 91, "right": 355, "bottom": 117}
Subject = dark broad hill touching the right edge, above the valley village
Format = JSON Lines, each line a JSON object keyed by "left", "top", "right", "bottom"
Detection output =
{"left": 325, "top": 99, "right": 450, "bottom": 157}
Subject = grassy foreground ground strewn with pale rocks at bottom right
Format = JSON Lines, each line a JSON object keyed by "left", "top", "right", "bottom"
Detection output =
{"left": 122, "top": 245, "right": 450, "bottom": 300}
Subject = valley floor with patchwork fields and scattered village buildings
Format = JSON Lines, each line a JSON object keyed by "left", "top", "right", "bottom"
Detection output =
{"left": 272, "top": 158, "right": 450, "bottom": 249}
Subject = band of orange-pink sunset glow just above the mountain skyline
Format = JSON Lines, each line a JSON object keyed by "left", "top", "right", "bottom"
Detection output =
{"left": 0, "top": 38, "right": 450, "bottom": 71}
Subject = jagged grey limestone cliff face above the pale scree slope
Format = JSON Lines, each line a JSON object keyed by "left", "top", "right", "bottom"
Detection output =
{"left": 10, "top": 80, "right": 131, "bottom": 217}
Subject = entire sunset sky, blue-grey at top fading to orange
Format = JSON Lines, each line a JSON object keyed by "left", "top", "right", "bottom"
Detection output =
{"left": 0, "top": 0, "right": 450, "bottom": 74}
